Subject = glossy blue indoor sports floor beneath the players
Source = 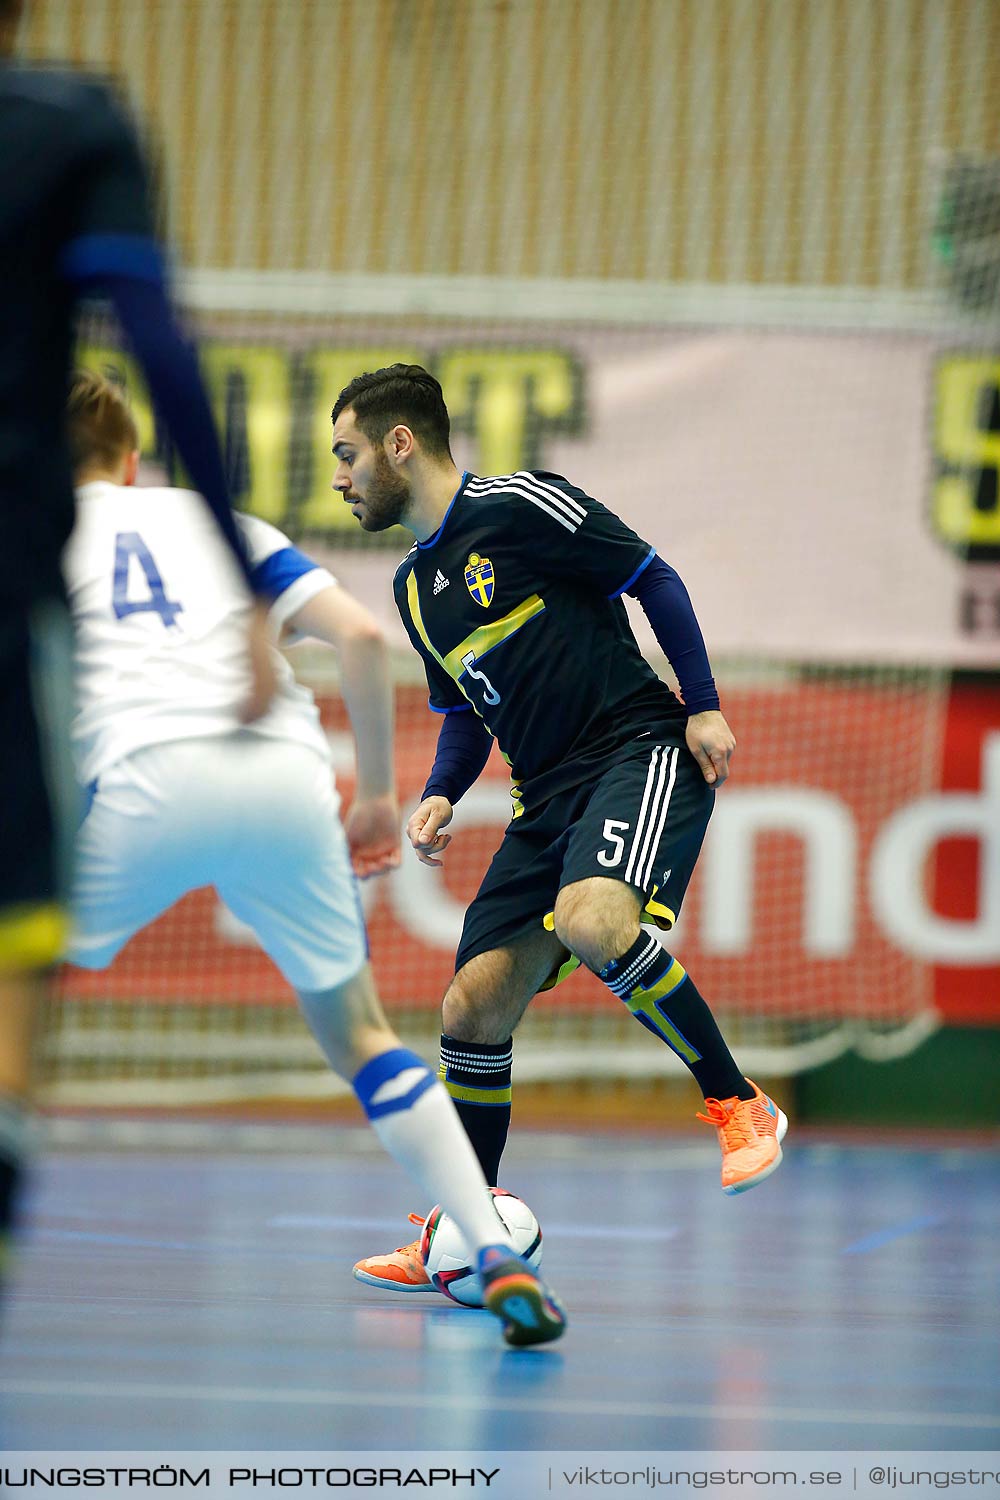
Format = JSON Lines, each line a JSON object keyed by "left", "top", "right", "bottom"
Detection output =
{"left": 0, "top": 1121, "right": 1000, "bottom": 1452}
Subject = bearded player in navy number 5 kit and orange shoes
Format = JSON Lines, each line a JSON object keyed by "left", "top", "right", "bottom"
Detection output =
{"left": 333, "top": 365, "right": 787, "bottom": 1292}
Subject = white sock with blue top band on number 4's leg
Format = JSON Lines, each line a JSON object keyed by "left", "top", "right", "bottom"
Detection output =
{"left": 352, "top": 1047, "right": 510, "bottom": 1251}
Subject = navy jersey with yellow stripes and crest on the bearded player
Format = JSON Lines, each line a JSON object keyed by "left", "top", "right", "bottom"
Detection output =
{"left": 394, "top": 473, "right": 687, "bottom": 806}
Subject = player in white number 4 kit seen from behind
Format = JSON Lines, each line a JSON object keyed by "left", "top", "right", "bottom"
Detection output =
{"left": 63, "top": 375, "right": 565, "bottom": 1344}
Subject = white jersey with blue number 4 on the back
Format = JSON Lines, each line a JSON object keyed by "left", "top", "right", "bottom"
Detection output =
{"left": 63, "top": 482, "right": 334, "bottom": 783}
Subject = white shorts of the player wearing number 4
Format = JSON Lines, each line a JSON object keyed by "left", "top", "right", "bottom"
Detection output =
{"left": 66, "top": 731, "right": 367, "bottom": 993}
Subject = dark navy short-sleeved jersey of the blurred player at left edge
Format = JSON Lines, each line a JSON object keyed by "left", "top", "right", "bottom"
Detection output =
{"left": 0, "top": 63, "right": 153, "bottom": 606}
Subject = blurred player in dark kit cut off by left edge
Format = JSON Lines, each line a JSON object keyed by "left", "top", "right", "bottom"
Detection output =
{"left": 0, "top": 0, "right": 274, "bottom": 1314}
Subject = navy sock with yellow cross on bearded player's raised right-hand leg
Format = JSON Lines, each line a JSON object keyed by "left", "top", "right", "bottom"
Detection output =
{"left": 598, "top": 932, "right": 754, "bottom": 1100}
